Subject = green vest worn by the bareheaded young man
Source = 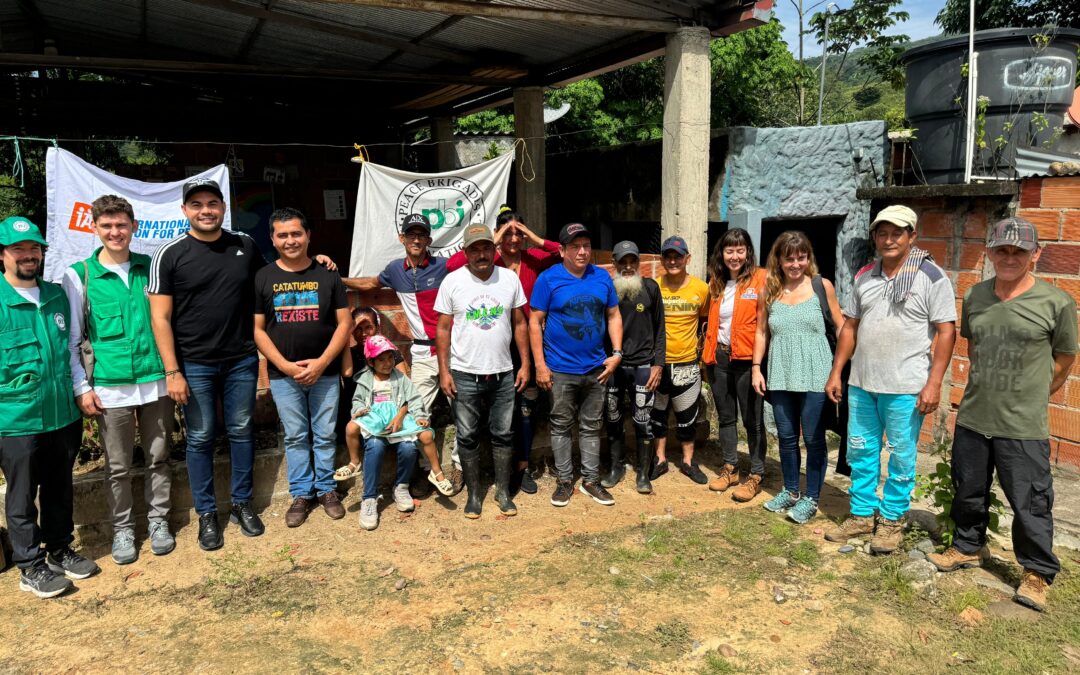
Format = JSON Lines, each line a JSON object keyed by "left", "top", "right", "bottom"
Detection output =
{"left": 71, "top": 248, "right": 165, "bottom": 387}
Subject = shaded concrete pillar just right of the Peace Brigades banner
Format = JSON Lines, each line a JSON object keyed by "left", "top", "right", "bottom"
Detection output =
{"left": 511, "top": 86, "right": 549, "bottom": 237}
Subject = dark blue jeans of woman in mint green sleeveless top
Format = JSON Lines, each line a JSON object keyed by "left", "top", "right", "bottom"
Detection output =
{"left": 769, "top": 391, "right": 828, "bottom": 501}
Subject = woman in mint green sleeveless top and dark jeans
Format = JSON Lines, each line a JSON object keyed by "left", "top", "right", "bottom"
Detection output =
{"left": 753, "top": 231, "right": 843, "bottom": 525}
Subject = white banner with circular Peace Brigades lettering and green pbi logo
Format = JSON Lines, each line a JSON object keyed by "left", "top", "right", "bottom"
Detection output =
{"left": 349, "top": 152, "right": 514, "bottom": 276}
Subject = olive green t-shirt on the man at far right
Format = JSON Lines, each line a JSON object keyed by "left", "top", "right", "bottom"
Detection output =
{"left": 956, "top": 279, "right": 1077, "bottom": 441}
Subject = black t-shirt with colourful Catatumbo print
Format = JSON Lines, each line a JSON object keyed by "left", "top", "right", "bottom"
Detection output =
{"left": 255, "top": 261, "right": 349, "bottom": 378}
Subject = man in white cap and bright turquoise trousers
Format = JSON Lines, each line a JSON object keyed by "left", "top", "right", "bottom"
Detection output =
{"left": 825, "top": 205, "right": 956, "bottom": 554}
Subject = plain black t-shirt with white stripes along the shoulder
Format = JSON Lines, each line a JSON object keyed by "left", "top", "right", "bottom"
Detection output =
{"left": 147, "top": 230, "right": 266, "bottom": 364}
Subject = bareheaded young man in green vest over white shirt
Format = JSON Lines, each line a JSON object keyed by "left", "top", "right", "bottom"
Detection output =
{"left": 64, "top": 194, "right": 176, "bottom": 565}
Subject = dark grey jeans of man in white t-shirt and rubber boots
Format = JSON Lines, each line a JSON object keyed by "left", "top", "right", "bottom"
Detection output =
{"left": 450, "top": 370, "right": 514, "bottom": 451}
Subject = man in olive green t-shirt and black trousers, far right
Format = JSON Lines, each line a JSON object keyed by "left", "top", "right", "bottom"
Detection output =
{"left": 927, "top": 218, "right": 1077, "bottom": 610}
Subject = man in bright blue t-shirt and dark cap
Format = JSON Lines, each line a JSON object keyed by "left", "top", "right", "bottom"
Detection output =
{"left": 529, "top": 222, "right": 622, "bottom": 507}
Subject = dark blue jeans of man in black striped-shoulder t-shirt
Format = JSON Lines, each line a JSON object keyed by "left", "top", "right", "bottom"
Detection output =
{"left": 184, "top": 354, "right": 259, "bottom": 515}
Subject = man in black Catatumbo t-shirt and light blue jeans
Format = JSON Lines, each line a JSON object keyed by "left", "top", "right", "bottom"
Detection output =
{"left": 255, "top": 208, "right": 352, "bottom": 527}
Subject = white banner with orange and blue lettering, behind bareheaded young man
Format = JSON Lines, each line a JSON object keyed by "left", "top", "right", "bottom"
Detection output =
{"left": 44, "top": 148, "right": 232, "bottom": 282}
